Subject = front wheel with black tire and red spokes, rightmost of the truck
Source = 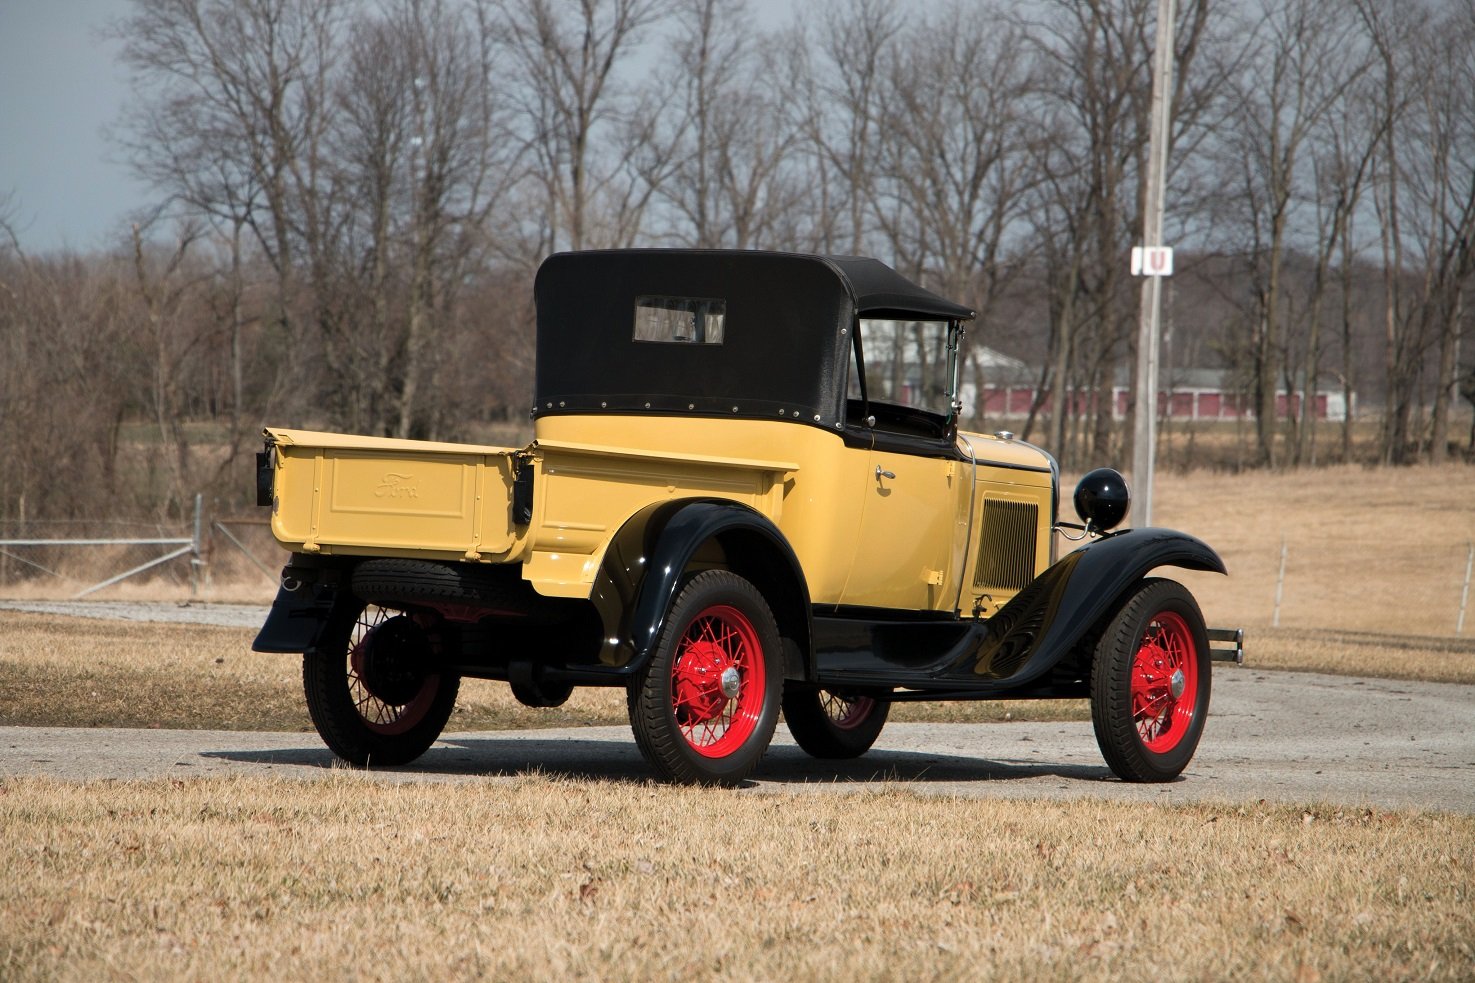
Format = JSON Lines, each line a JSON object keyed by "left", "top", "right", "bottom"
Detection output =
{"left": 1092, "top": 580, "right": 1211, "bottom": 782}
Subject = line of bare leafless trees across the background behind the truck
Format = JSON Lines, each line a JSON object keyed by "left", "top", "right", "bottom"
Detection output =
{"left": 0, "top": 0, "right": 1475, "bottom": 518}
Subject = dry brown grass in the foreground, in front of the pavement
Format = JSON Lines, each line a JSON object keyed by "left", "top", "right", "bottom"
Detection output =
{"left": 0, "top": 773, "right": 1475, "bottom": 983}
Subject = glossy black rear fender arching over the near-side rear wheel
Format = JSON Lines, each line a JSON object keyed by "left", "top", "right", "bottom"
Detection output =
{"left": 590, "top": 499, "right": 813, "bottom": 679}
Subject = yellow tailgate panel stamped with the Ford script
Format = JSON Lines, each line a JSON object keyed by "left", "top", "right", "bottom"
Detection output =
{"left": 263, "top": 428, "right": 521, "bottom": 561}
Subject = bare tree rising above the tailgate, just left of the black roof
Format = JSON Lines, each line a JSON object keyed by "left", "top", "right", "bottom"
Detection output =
{"left": 332, "top": 0, "right": 516, "bottom": 437}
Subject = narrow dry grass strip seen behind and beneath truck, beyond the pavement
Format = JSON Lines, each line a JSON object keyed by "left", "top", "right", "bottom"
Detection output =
{"left": 0, "top": 611, "right": 1475, "bottom": 731}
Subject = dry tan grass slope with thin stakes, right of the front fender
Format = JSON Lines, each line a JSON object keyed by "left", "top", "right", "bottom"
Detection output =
{"left": 1144, "top": 465, "right": 1475, "bottom": 638}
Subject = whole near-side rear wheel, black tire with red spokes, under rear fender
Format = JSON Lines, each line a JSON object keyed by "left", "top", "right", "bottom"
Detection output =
{"left": 628, "top": 570, "right": 783, "bottom": 785}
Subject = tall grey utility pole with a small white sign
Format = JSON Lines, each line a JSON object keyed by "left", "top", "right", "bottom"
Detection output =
{"left": 1131, "top": 0, "right": 1177, "bottom": 525}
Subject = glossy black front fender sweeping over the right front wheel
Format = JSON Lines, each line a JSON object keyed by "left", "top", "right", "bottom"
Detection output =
{"left": 948, "top": 528, "right": 1229, "bottom": 688}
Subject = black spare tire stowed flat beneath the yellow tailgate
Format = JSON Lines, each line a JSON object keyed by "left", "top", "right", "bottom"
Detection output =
{"left": 351, "top": 558, "right": 530, "bottom": 614}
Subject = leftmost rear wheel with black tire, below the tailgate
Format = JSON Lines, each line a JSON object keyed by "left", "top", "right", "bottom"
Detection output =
{"left": 302, "top": 602, "right": 460, "bottom": 768}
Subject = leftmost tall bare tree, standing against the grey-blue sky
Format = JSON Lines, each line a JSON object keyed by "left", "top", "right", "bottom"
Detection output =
{"left": 114, "top": 0, "right": 347, "bottom": 432}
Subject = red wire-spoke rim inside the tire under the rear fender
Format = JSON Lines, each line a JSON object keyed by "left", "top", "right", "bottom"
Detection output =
{"left": 671, "top": 605, "right": 767, "bottom": 757}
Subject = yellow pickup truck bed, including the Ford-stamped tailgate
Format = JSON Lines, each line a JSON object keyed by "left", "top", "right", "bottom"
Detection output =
{"left": 263, "top": 428, "right": 798, "bottom": 596}
